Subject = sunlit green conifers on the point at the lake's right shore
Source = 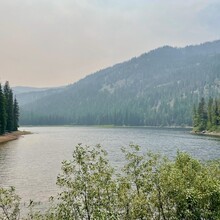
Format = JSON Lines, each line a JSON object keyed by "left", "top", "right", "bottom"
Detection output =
{"left": 193, "top": 98, "right": 220, "bottom": 132}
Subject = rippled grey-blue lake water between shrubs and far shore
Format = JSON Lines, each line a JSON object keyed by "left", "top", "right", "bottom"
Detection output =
{"left": 0, "top": 127, "right": 220, "bottom": 202}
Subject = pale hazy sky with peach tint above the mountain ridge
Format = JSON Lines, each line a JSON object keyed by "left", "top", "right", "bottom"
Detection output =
{"left": 0, "top": 0, "right": 220, "bottom": 87}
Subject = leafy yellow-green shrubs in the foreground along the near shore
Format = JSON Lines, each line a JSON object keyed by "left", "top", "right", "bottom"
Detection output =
{"left": 0, "top": 144, "right": 220, "bottom": 220}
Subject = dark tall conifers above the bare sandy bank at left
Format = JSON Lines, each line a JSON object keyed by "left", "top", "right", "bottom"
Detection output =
{"left": 0, "top": 81, "right": 19, "bottom": 135}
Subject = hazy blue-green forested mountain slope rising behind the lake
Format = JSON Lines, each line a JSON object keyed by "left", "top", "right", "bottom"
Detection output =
{"left": 19, "top": 40, "right": 220, "bottom": 126}
